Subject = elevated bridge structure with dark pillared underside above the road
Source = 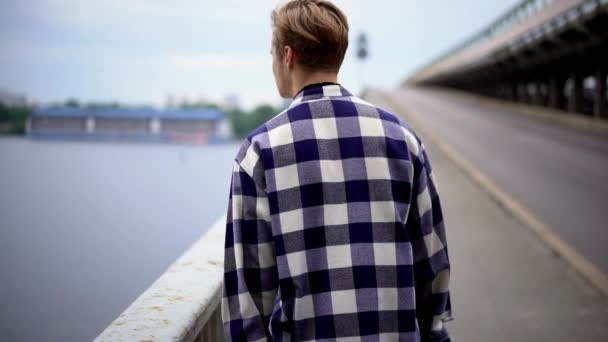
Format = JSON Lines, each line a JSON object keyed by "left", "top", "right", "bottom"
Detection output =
{"left": 405, "top": 0, "right": 608, "bottom": 119}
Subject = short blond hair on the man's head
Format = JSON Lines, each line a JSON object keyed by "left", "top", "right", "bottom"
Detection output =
{"left": 270, "top": 0, "right": 348, "bottom": 72}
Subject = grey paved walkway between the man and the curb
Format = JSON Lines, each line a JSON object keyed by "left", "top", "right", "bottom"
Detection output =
{"left": 408, "top": 124, "right": 608, "bottom": 342}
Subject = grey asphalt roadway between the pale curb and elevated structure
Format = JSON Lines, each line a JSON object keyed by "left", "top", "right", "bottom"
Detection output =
{"left": 370, "top": 87, "right": 608, "bottom": 273}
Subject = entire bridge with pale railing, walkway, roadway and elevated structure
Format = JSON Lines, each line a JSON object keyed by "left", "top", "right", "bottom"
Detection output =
{"left": 97, "top": 0, "right": 608, "bottom": 341}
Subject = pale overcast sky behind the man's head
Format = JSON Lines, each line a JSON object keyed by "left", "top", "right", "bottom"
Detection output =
{"left": 0, "top": 0, "right": 518, "bottom": 107}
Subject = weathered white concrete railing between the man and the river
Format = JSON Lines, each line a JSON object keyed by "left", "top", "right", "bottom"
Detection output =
{"left": 95, "top": 217, "right": 226, "bottom": 342}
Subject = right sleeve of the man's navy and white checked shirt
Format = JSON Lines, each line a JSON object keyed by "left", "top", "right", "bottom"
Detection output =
{"left": 406, "top": 144, "right": 453, "bottom": 342}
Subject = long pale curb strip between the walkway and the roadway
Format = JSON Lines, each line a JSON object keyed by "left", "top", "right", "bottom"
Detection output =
{"left": 375, "top": 91, "right": 608, "bottom": 297}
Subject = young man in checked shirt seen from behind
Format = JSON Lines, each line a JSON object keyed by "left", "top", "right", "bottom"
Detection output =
{"left": 222, "top": 0, "right": 452, "bottom": 341}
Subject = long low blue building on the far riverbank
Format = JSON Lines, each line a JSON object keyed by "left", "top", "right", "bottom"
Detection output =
{"left": 27, "top": 107, "right": 228, "bottom": 144}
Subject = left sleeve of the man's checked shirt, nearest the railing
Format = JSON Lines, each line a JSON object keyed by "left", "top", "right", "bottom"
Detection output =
{"left": 222, "top": 161, "right": 278, "bottom": 341}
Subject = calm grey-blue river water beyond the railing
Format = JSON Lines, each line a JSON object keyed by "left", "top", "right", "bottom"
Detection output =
{"left": 0, "top": 137, "right": 238, "bottom": 341}
